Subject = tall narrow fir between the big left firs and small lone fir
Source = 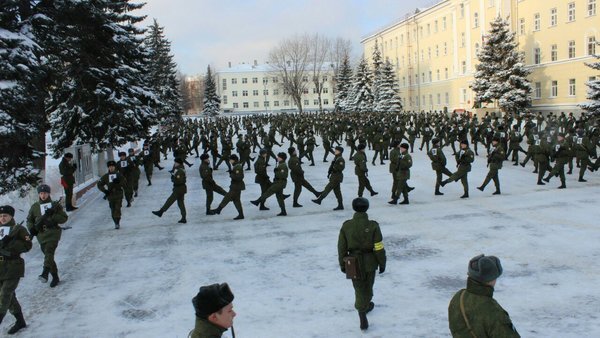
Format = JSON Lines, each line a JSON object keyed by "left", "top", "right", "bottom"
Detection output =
{"left": 144, "top": 19, "right": 183, "bottom": 118}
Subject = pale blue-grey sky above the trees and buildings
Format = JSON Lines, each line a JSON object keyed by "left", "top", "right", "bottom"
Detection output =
{"left": 137, "top": 0, "right": 439, "bottom": 75}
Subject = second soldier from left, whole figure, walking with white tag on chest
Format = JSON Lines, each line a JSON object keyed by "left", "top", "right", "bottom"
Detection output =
{"left": 27, "top": 184, "right": 69, "bottom": 288}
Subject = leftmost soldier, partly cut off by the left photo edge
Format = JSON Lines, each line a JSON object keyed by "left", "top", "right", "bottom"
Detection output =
{"left": 0, "top": 205, "right": 32, "bottom": 334}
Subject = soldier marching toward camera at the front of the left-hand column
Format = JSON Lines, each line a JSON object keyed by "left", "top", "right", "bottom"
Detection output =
{"left": 97, "top": 161, "right": 127, "bottom": 229}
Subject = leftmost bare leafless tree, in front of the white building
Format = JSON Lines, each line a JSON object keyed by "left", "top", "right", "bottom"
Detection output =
{"left": 269, "top": 34, "right": 311, "bottom": 113}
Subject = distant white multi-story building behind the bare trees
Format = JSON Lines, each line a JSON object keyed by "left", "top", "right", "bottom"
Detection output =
{"left": 215, "top": 62, "right": 334, "bottom": 112}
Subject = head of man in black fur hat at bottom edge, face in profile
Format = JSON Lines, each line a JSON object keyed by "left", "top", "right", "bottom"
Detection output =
{"left": 189, "top": 283, "right": 236, "bottom": 338}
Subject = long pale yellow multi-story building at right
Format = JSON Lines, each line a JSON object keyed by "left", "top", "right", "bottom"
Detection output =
{"left": 362, "top": 0, "right": 600, "bottom": 113}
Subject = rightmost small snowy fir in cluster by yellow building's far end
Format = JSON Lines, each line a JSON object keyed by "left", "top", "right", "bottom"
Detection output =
{"left": 373, "top": 60, "right": 402, "bottom": 113}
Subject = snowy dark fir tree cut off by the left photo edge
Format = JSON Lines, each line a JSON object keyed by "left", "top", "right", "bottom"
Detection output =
{"left": 0, "top": 0, "right": 45, "bottom": 194}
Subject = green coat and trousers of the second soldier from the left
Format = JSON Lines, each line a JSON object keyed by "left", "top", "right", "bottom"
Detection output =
{"left": 27, "top": 199, "right": 69, "bottom": 274}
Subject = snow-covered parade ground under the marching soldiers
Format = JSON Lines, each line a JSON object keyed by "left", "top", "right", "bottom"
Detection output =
{"left": 0, "top": 133, "right": 600, "bottom": 338}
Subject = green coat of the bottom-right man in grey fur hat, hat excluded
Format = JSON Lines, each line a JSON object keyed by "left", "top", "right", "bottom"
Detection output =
{"left": 448, "top": 278, "right": 521, "bottom": 338}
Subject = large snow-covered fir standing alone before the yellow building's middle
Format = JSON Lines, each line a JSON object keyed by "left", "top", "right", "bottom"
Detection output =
{"left": 471, "top": 17, "right": 531, "bottom": 113}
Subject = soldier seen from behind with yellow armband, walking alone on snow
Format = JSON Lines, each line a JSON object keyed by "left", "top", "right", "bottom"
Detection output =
{"left": 338, "top": 197, "right": 386, "bottom": 330}
